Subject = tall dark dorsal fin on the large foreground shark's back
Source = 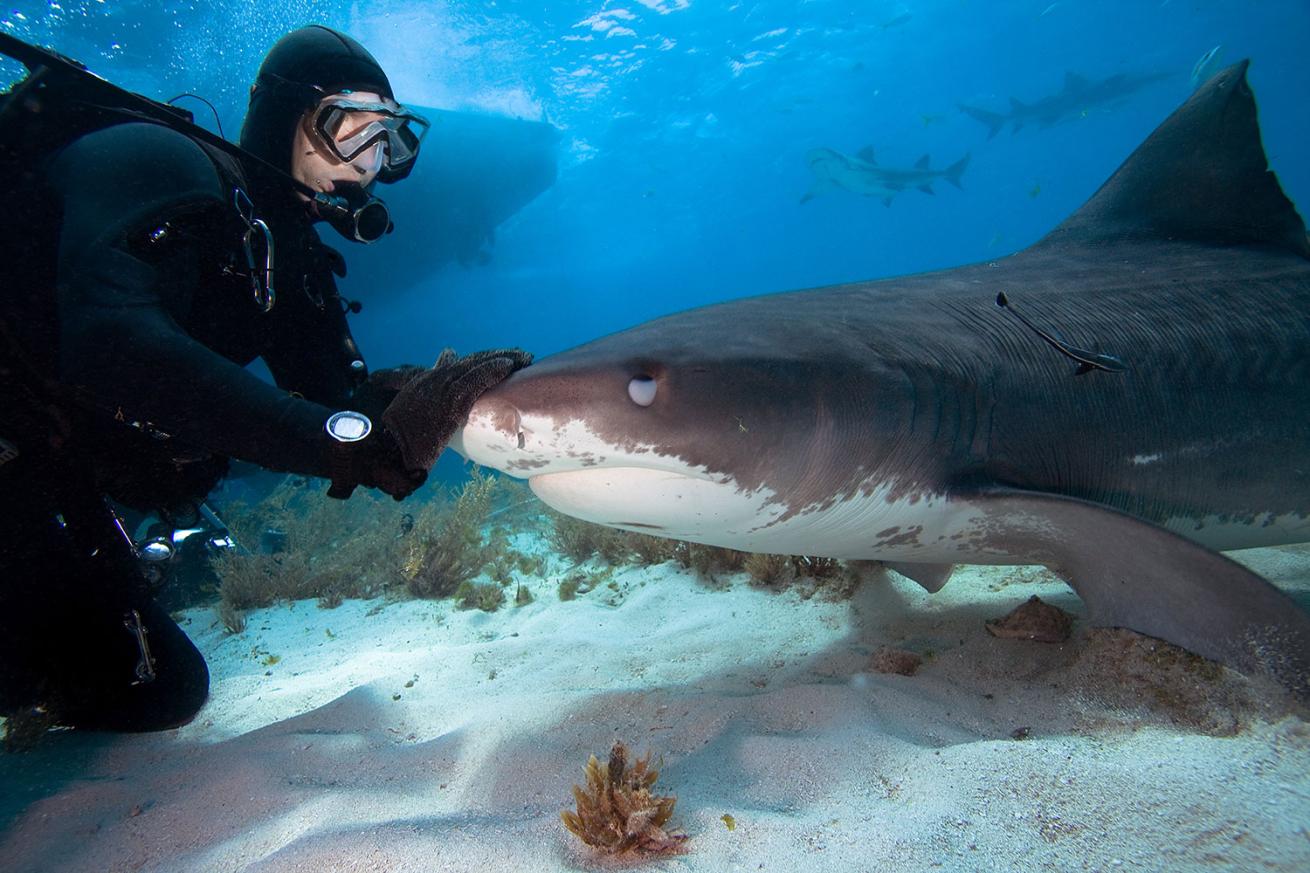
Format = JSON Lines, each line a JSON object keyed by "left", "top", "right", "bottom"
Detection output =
{"left": 1038, "top": 60, "right": 1310, "bottom": 258}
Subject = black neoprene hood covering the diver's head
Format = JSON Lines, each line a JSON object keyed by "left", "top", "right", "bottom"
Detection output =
{"left": 241, "top": 25, "right": 394, "bottom": 173}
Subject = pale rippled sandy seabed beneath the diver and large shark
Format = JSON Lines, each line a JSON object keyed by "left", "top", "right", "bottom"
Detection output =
{"left": 0, "top": 537, "right": 1310, "bottom": 873}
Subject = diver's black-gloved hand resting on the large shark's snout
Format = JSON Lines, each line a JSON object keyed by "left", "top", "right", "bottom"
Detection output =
{"left": 383, "top": 349, "right": 532, "bottom": 471}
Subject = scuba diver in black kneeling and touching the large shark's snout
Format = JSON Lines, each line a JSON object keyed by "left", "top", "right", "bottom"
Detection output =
{"left": 0, "top": 25, "right": 531, "bottom": 731}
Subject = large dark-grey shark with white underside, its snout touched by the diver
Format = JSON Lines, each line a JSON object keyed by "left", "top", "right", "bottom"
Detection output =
{"left": 455, "top": 62, "right": 1310, "bottom": 695}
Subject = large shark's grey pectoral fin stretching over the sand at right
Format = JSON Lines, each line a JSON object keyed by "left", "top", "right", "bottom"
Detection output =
{"left": 971, "top": 489, "right": 1310, "bottom": 699}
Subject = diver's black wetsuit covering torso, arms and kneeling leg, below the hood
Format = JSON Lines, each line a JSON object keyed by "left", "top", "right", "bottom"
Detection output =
{"left": 0, "top": 123, "right": 385, "bottom": 730}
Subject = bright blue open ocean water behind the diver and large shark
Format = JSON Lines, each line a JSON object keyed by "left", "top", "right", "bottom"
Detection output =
{"left": 0, "top": 0, "right": 1310, "bottom": 414}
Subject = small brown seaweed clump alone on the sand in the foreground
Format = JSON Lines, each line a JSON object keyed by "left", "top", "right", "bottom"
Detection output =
{"left": 559, "top": 742, "right": 686, "bottom": 855}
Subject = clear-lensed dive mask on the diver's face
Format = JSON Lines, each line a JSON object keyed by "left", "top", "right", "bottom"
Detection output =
{"left": 310, "top": 92, "right": 431, "bottom": 182}
